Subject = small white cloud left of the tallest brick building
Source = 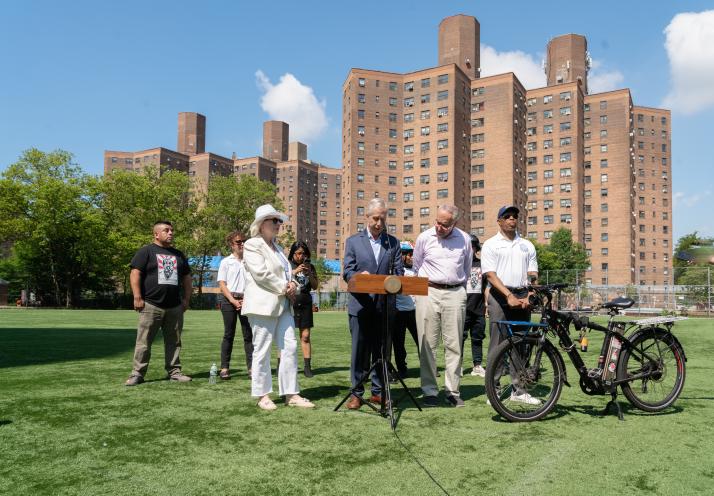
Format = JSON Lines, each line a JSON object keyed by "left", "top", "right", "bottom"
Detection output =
{"left": 255, "top": 70, "right": 328, "bottom": 144}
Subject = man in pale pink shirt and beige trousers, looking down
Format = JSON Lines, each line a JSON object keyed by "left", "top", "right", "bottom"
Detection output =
{"left": 412, "top": 205, "right": 472, "bottom": 407}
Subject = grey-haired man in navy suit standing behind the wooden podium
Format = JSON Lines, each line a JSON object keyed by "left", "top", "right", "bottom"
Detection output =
{"left": 342, "top": 198, "right": 404, "bottom": 410}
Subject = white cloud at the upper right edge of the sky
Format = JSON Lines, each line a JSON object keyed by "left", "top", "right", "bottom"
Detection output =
{"left": 663, "top": 10, "right": 714, "bottom": 114}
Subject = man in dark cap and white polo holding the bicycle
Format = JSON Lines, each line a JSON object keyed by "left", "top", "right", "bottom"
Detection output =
{"left": 481, "top": 205, "right": 538, "bottom": 403}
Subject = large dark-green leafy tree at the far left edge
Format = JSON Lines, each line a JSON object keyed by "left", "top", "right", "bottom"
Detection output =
{"left": 0, "top": 148, "right": 112, "bottom": 307}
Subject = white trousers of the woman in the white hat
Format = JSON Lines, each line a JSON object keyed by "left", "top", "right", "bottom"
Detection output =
{"left": 248, "top": 306, "right": 300, "bottom": 397}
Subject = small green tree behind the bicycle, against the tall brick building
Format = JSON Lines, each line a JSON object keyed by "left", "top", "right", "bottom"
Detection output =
{"left": 534, "top": 227, "right": 590, "bottom": 284}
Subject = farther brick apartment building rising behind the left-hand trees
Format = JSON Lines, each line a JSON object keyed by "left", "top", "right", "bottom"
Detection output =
{"left": 104, "top": 112, "right": 341, "bottom": 258}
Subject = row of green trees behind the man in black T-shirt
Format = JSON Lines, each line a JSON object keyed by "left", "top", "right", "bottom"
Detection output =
{"left": 0, "top": 149, "right": 282, "bottom": 306}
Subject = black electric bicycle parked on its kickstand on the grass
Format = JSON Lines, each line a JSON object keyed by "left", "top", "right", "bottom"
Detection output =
{"left": 485, "top": 284, "right": 687, "bottom": 422}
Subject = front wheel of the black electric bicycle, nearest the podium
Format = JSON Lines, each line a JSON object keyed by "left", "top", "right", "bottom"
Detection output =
{"left": 486, "top": 337, "right": 564, "bottom": 422}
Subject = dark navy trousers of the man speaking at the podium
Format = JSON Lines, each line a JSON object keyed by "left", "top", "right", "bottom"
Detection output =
{"left": 349, "top": 310, "right": 388, "bottom": 397}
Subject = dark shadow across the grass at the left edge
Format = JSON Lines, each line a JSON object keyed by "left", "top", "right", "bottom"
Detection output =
{"left": 0, "top": 328, "right": 136, "bottom": 369}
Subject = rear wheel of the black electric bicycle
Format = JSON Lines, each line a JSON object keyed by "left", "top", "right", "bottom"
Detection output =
{"left": 618, "top": 328, "right": 686, "bottom": 412}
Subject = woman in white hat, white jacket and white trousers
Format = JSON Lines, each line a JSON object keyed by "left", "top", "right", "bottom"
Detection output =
{"left": 242, "top": 205, "right": 315, "bottom": 410}
